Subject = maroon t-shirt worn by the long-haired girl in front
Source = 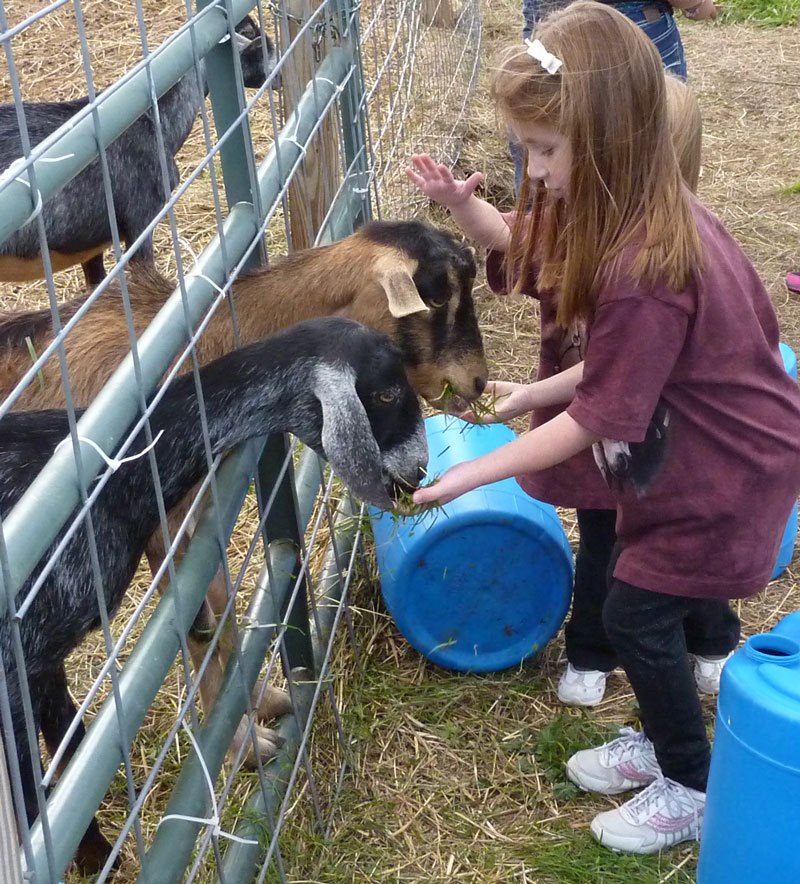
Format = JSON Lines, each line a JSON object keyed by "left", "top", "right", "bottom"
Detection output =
{"left": 567, "top": 201, "right": 800, "bottom": 598}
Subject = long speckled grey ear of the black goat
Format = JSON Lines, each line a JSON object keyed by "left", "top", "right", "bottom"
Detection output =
{"left": 314, "top": 364, "right": 392, "bottom": 509}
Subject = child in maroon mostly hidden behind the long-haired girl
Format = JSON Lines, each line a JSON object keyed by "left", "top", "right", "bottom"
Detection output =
{"left": 412, "top": 75, "right": 740, "bottom": 706}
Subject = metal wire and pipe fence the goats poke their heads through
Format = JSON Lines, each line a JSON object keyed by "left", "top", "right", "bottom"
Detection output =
{"left": 0, "top": 0, "right": 480, "bottom": 884}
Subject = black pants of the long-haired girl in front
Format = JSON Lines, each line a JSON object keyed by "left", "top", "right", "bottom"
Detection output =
{"left": 603, "top": 580, "right": 733, "bottom": 792}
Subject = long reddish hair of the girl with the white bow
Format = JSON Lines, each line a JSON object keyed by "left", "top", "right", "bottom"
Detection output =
{"left": 492, "top": 0, "right": 702, "bottom": 326}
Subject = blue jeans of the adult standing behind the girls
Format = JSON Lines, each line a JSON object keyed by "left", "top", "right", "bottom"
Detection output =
{"left": 508, "top": 0, "right": 686, "bottom": 193}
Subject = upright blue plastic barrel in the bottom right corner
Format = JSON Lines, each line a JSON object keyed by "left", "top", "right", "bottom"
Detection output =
{"left": 697, "top": 615, "right": 800, "bottom": 884}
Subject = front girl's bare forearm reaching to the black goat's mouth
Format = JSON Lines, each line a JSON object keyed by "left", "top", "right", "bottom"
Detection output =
{"left": 414, "top": 411, "right": 600, "bottom": 504}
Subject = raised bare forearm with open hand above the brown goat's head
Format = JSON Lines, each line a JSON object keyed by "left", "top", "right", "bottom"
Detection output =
{"left": 406, "top": 154, "right": 511, "bottom": 252}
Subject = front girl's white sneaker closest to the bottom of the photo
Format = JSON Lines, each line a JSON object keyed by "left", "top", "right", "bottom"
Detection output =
{"left": 591, "top": 777, "right": 706, "bottom": 853}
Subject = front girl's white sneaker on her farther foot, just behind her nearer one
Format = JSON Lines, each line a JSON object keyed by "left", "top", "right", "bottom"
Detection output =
{"left": 567, "top": 727, "right": 661, "bottom": 795}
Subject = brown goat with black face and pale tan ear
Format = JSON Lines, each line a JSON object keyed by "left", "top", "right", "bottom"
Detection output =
{"left": 0, "top": 221, "right": 487, "bottom": 760}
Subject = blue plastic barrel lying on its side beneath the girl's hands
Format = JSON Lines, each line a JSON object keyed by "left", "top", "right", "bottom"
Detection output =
{"left": 370, "top": 415, "right": 572, "bottom": 672}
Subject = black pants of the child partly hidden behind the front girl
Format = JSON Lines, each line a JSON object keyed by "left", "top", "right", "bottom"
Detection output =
{"left": 564, "top": 510, "right": 740, "bottom": 672}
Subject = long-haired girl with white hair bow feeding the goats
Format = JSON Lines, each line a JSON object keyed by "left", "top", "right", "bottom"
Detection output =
{"left": 412, "top": 0, "right": 800, "bottom": 853}
